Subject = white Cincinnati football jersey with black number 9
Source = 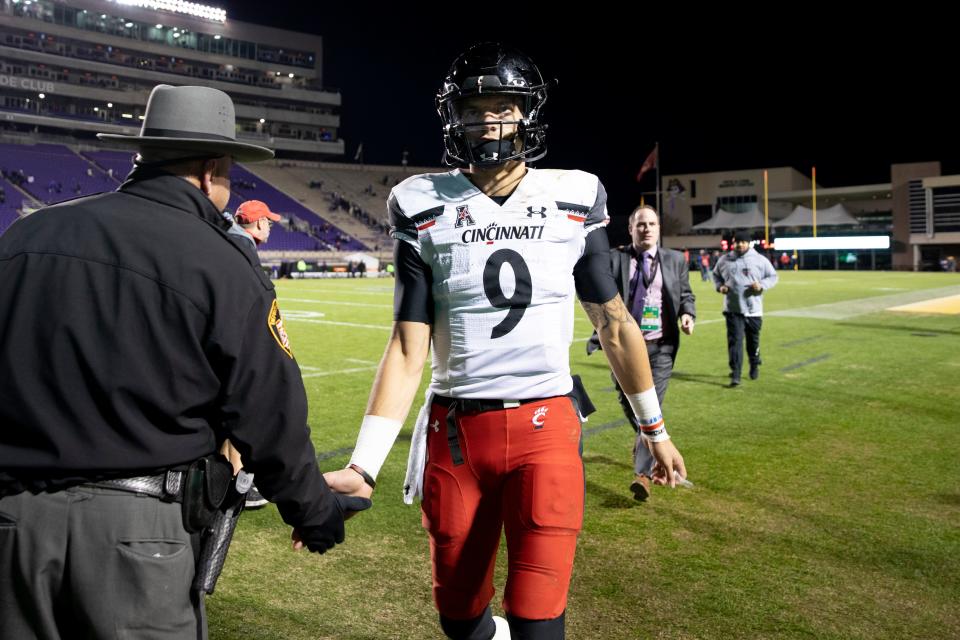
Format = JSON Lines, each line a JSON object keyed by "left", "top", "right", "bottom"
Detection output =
{"left": 389, "top": 168, "right": 609, "bottom": 400}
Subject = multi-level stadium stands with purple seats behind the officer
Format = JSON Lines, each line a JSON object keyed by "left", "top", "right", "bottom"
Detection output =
{"left": 0, "top": 0, "right": 419, "bottom": 270}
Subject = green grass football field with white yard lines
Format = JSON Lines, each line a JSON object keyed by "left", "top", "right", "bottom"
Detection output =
{"left": 207, "top": 272, "right": 960, "bottom": 640}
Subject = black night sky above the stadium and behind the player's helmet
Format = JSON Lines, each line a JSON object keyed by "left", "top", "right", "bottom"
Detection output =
{"left": 227, "top": 1, "right": 960, "bottom": 220}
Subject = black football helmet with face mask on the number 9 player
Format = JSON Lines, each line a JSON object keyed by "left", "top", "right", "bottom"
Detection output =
{"left": 437, "top": 42, "right": 548, "bottom": 167}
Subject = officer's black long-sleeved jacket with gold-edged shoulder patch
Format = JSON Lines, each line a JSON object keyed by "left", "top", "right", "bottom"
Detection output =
{"left": 0, "top": 169, "right": 332, "bottom": 526}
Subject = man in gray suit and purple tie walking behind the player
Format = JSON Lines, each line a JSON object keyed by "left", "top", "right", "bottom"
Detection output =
{"left": 587, "top": 205, "right": 697, "bottom": 501}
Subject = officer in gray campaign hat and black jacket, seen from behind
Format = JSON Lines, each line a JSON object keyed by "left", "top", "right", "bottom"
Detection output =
{"left": 0, "top": 85, "right": 369, "bottom": 638}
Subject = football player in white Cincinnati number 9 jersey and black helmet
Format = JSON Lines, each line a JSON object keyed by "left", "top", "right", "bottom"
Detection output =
{"left": 326, "top": 43, "right": 686, "bottom": 640}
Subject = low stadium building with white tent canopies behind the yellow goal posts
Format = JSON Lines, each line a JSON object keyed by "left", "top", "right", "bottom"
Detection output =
{"left": 661, "top": 162, "right": 960, "bottom": 271}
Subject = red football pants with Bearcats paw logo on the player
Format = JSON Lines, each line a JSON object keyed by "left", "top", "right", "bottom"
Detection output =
{"left": 422, "top": 396, "right": 584, "bottom": 620}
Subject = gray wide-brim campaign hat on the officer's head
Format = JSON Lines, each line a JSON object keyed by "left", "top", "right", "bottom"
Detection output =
{"left": 97, "top": 84, "right": 273, "bottom": 162}
